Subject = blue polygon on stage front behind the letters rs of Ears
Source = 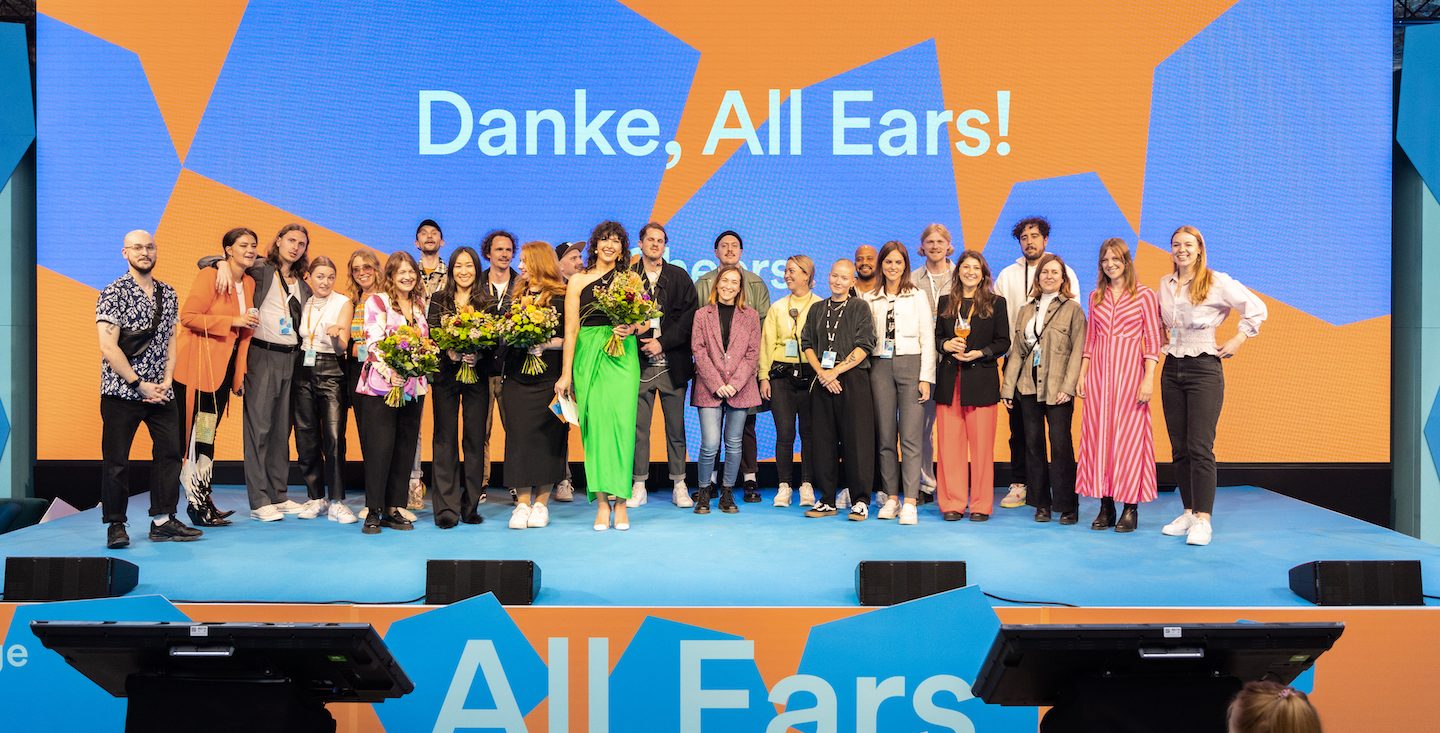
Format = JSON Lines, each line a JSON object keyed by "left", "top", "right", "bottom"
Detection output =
{"left": 786, "top": 586, "right": 1038, "bottom": 733}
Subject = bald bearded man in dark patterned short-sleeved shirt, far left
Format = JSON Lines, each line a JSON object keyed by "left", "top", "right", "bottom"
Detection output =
{"left": 95, "top": 229, "right": 202, "bottom": 550}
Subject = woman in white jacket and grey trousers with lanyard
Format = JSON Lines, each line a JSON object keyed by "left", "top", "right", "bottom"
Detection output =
{"left": 865, "top": 242, "right": 935, "bottom": 524}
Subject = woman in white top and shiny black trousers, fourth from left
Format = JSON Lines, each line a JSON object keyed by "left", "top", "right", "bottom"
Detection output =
{"left": 291, "top": 256, "right": 356, "bottom": 524}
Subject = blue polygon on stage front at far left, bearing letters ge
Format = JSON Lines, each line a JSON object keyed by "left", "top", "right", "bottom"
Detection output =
{"left": 0, "top": 593, "right": 190, "bottom": 733}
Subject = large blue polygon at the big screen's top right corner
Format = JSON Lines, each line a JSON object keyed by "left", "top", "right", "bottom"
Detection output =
{"left": 1140, "top": 0, "right": 1393, "bottom": 324}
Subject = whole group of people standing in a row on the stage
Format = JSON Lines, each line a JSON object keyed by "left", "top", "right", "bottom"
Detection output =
{"left": 96, "top": 211, "right": 1266, "bottom": 547}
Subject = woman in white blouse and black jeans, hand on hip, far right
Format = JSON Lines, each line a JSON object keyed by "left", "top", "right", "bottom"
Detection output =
{"left": 1161, "top": 226, "right": 1267, "bottom": 544}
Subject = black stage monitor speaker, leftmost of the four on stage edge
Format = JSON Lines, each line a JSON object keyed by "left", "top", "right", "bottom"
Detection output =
{"left": 4, "top": 557, "right": 140, "bottom": 601}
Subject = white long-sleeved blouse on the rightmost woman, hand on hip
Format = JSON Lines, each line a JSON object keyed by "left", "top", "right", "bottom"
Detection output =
{"left": 1161, "top": 272, "right": 1269, "bottom": 356}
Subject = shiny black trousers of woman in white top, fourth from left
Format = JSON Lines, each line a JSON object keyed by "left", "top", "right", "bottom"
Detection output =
{"left": 292, "top": 354, "right": 346, "bottom": 501}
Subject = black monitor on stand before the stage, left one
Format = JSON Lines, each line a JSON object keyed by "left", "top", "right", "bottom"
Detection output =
{"left": 30, "top": 621, "right": 415, "bottom": 733}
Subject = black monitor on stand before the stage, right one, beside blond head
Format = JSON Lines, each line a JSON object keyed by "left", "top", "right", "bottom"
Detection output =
{"left": 973, "top": 624, "right": 1345, "bottom": 733}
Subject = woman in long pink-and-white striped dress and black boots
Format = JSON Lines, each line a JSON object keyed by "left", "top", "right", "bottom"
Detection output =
{"left": 1076, "top": 239, "right": 1162, "bottom": 531}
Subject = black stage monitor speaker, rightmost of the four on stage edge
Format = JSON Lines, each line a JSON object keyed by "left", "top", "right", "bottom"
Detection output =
{"left": 1290, "top": 560, "right": 1424, "bottom": 606}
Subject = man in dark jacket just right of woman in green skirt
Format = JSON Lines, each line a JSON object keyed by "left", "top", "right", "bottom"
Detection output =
{"left": 626, "top": 222, "right": 699, "bottom": 507}
